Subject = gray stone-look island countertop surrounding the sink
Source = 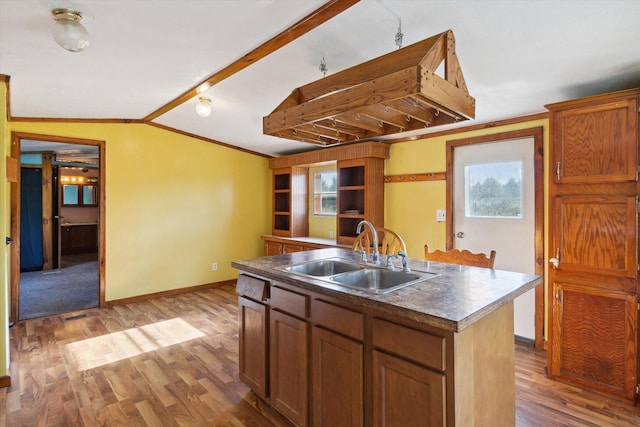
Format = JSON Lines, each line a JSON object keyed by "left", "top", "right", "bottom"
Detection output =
{"left": 231, "top": 248, "right": 542, "bottom": 332}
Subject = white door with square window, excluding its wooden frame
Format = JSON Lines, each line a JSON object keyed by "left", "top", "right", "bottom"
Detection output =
{"left": 453, "top": 137, "right": 536, "bottom": 340}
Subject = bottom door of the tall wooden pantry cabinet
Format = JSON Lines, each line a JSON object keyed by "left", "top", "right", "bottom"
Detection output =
{"left": 550, "top": 283, "right": 638, "bottom": 399}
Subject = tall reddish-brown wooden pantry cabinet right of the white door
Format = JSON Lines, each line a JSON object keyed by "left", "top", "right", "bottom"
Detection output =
{"left": 547, "top": 89, "right": 640, "bottom": 399}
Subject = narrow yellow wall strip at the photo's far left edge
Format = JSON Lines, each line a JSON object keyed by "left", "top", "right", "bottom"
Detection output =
{"left": 0, "top": 75, "right": 11, "bottom": 377}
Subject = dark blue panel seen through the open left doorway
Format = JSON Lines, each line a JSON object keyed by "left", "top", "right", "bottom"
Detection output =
{"left": 20, "top": 168, "right": 44, "bottom": 271}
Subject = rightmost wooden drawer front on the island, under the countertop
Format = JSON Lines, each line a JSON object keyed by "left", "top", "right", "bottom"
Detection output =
{"left": 373, "top": 318, "right": 445, "bottom": 371}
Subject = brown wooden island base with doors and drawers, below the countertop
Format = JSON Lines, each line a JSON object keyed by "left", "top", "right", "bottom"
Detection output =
{"left": 236, "top": 273, "right": 515, "bottom": 427}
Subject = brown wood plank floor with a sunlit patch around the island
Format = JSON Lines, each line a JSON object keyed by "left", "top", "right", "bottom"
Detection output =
{"left": 0, "top": 286, "right": 640, "bottom": 427}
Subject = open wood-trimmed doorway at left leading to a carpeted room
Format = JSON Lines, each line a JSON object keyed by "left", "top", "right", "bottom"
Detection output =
{"left": 10, "top": 132, "right": 105, "bottom": 322}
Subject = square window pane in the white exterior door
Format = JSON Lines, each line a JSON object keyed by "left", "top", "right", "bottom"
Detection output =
{"left": 464, "top": 161, "right": 522, "bottom": 218}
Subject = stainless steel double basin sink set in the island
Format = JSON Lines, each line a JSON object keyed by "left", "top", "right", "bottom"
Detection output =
{"left": 278, "top": 258, "right": 439, "bottom": 294}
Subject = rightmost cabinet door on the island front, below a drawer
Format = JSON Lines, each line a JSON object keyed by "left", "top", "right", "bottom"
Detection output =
{"left": 373, "top": 350, "right": 446, "bottom": 427}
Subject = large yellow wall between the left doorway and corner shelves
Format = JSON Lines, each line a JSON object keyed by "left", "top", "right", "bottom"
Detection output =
{"left": 10, "top": 122, "right": 271, "bottom": 301}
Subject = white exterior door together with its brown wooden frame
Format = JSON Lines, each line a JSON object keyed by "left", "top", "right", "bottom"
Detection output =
{"left": 447, "top": 128, "right": 544, "bottom": 348}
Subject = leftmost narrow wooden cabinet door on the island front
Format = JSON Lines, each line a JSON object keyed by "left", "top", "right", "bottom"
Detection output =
{"left": 238, "top": 297, "right": 268, "bottom": 397}
